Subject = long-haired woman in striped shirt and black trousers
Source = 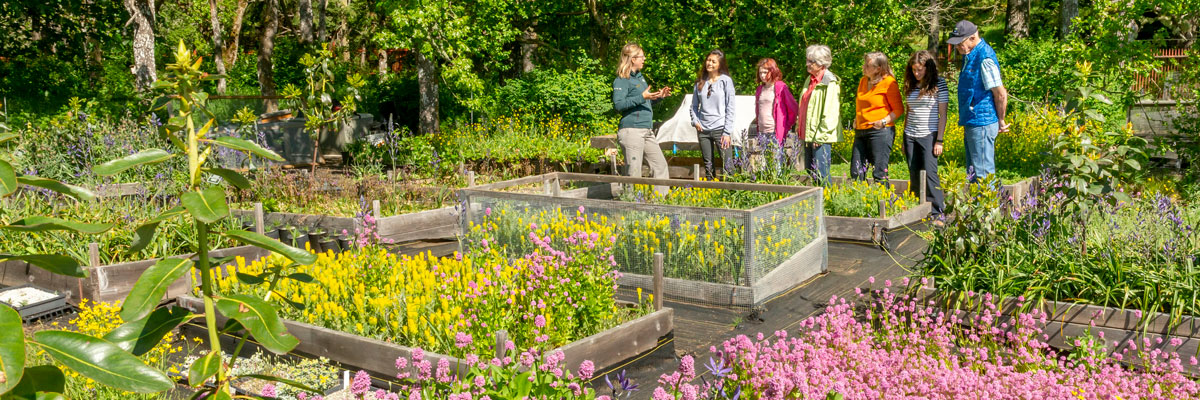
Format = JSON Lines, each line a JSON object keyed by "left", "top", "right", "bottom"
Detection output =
{"left": 901, "top": 50, "right": 950, "bottom": 219}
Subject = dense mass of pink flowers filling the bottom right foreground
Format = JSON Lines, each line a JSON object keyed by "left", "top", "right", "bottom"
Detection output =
{"left": 653, "top": 279, "right": 1200, "bottom": 400}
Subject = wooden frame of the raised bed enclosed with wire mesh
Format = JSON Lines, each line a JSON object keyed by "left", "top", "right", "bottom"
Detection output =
{"left": 460, "top": 173, "right": 829, "bottom": 308}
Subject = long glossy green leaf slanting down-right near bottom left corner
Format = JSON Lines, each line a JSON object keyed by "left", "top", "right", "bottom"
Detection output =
{"left": 34, "top": 330, "right": 174, "bottom": 393}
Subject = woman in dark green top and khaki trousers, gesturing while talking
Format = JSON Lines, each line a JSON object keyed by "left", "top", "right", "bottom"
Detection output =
{"left": 612, "top": 43, "right": 671, "bottom": 182}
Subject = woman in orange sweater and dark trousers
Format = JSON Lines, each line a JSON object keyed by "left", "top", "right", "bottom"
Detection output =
{"left": 850, "top": 52, "right": 904, "bottom": 185}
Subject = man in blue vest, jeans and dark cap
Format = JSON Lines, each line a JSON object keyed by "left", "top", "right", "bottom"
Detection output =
{"left": 946, "top": 20, "right": 1008, "bottom": 183}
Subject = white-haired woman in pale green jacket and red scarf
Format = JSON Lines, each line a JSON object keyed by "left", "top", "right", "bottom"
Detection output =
{"left": 796, "top": 44, "right": 841, "bottom": 185}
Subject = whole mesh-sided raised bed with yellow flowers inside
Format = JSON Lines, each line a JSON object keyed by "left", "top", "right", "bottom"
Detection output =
{"left": 460, "top": 173, "right": 827, "bottom": 306}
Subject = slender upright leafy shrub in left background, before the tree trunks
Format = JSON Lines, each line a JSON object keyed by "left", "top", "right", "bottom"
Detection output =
{"left": 282, "top": 44, "right": 364, "bottom": 172}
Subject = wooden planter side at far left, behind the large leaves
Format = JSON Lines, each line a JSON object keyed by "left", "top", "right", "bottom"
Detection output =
{"left": 0, "top": 242, "right": 268, "bottom": 305}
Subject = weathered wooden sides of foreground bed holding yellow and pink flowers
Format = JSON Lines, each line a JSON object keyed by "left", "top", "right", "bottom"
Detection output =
{"left": 179, "top": 297, "right": 674, "bottom": 377}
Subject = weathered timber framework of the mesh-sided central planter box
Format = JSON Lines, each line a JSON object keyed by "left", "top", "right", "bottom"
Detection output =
{"left": 458, "top": 173, "right": 828, "bottom": 306}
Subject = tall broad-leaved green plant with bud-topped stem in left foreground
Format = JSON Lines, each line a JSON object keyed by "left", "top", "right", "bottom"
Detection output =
{"left": 0, "top": 42, "right": 316, "bottom": 399}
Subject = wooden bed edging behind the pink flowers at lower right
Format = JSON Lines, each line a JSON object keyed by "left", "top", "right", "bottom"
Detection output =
{"left": 917, "top": 288, "right": 1200, "bottom": 376}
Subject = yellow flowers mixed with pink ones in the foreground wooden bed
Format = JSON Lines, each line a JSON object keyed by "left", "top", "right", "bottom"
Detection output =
{"left": 216, "top": 224, "right": 649, "bottom": 356}
